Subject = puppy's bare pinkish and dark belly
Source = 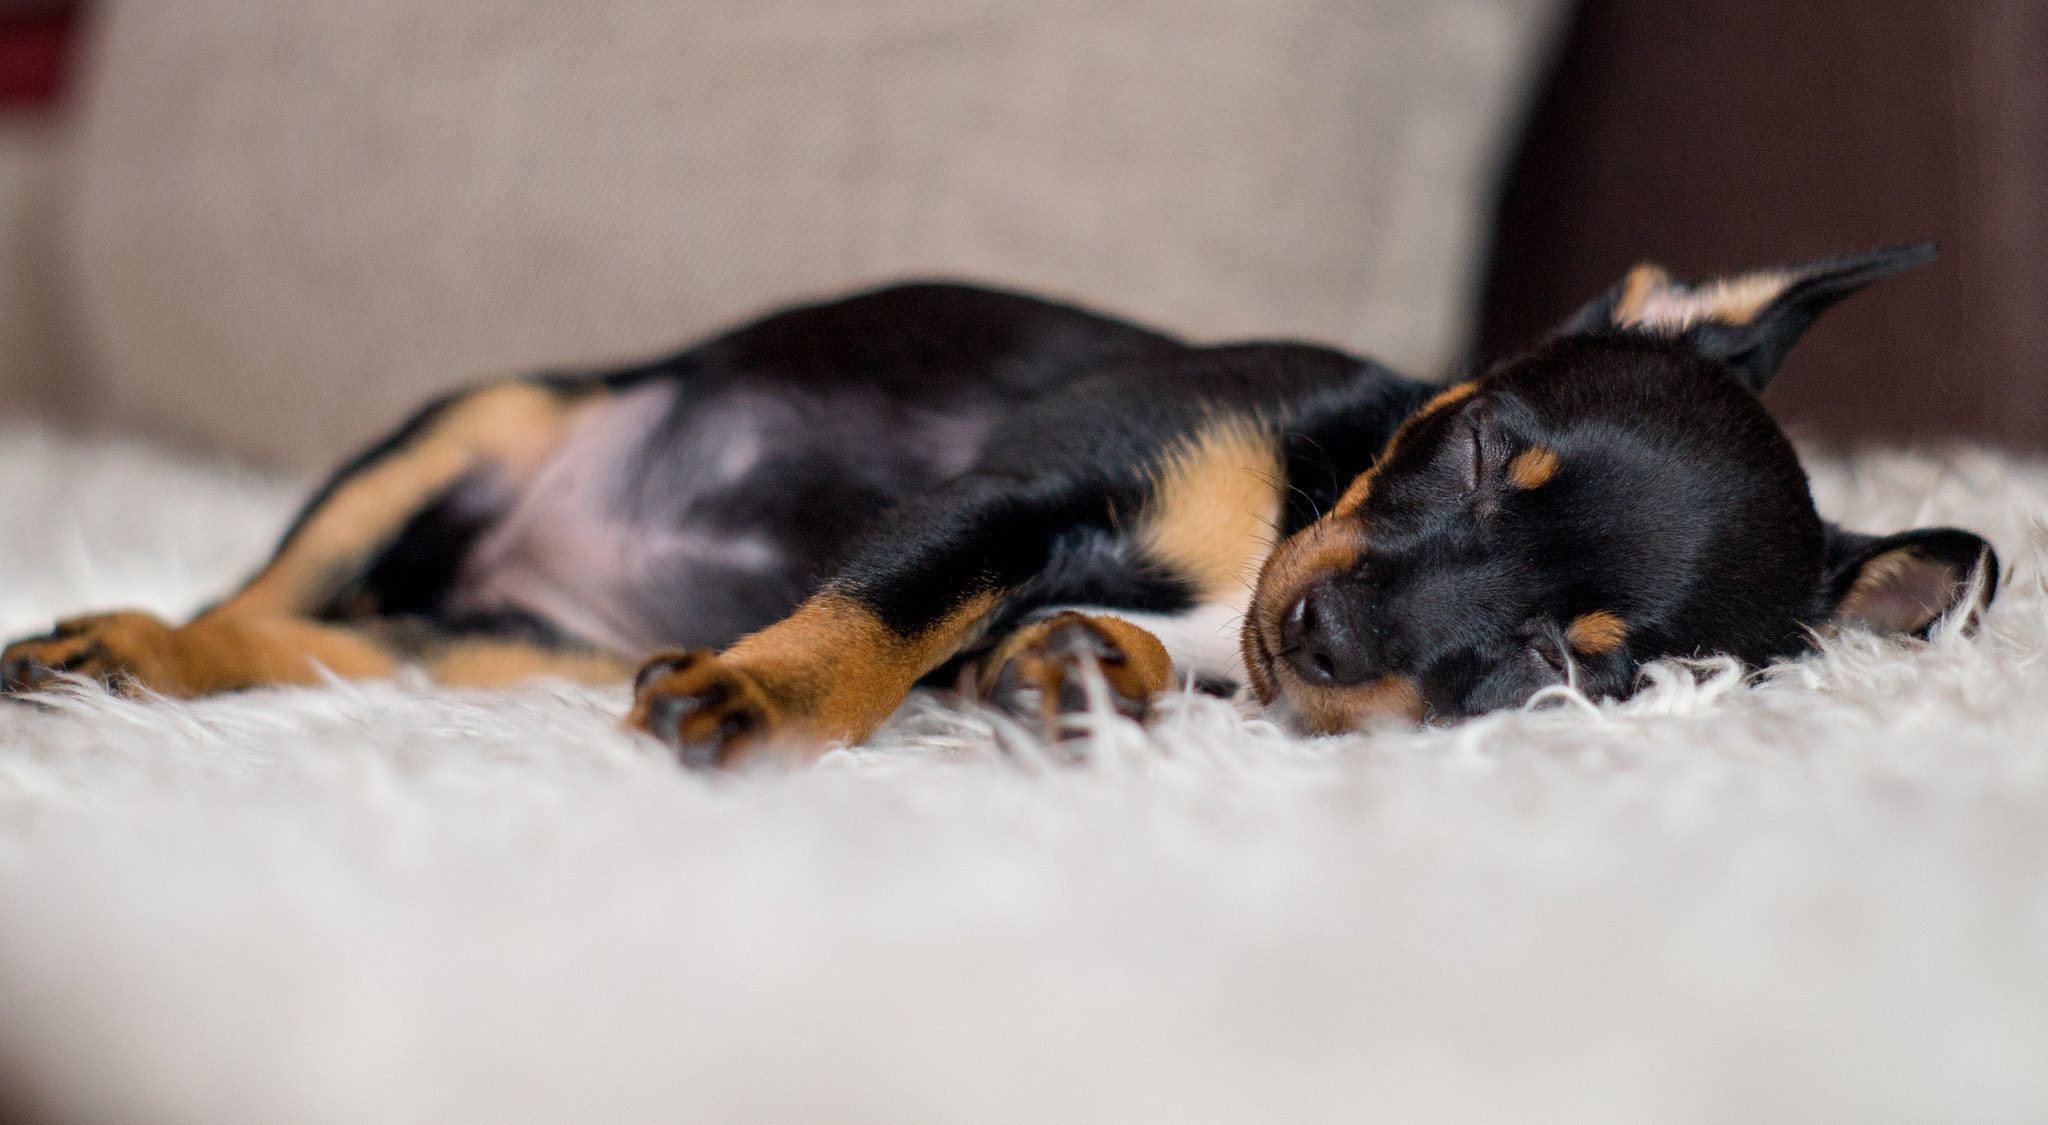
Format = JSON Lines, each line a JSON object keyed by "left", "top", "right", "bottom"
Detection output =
{"left": 444, "top": 381, "right": 987, "bottom": 658}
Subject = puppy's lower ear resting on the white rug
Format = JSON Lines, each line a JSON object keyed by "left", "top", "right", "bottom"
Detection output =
{"left": 1821, "top": 525, "right": 1999, "bottom": 637}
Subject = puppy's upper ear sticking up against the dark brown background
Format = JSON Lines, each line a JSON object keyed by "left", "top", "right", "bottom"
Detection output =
{"left": 1559, "top": 242, "right": 1935, "bottom": 393}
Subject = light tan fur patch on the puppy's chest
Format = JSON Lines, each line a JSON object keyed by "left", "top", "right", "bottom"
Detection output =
{"left": 1143, "top": 424, "right": 1284, "bottom": 600}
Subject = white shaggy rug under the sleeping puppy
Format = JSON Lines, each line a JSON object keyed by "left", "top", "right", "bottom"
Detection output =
{"left": 0, "top": 428, "right": 2048, "bottom": 1125}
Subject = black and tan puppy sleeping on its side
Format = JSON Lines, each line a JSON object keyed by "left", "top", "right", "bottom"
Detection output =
{"left": 0, "top": 246, "right": 1997, "bottom": 764}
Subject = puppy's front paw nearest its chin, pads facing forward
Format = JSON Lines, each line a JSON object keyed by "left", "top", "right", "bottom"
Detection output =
{"left": 981, "top": 611, "right": 1174, "bottom": 738}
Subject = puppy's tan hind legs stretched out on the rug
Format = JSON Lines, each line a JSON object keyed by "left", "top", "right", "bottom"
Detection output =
{"left": 0, "top": 381, "right": 631, "bottom": 697}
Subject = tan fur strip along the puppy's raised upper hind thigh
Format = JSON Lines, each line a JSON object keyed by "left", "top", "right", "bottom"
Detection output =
{"left": 229, "top": 383, "right": 573, "bottom": 617}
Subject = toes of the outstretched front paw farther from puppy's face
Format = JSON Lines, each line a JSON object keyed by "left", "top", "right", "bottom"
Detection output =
{"left": 627, "top": 648, "right": 778, "bottom": 768}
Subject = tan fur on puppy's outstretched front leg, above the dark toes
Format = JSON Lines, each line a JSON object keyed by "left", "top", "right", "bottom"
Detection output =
{"left": 719, "top": 592, "right": 999, "bottom": 742}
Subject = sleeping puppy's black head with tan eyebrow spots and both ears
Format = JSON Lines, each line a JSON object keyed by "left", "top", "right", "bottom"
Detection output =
{"left": 1243, "top": 246, "right": 1997, "bottom": 732}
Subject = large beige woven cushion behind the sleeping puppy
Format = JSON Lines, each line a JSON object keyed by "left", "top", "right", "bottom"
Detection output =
{"left": 72, "top": 0, "right": 1559, "bottom": 465}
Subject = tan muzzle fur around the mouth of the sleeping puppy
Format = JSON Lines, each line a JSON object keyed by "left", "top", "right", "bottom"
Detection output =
{"left": 1243, "top": 516, "right": 1427, "bottom": 734}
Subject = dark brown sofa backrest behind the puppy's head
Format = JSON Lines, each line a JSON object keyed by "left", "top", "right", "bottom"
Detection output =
{"left": 1479, "top": 0, "right": 2048, "bottom": 449}
